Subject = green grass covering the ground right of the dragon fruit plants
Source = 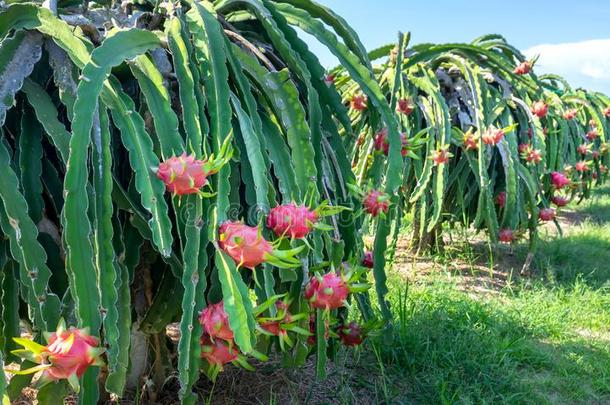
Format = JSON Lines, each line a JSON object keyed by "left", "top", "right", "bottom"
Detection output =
{"left": 363, "top": 188, "right": 610, "bottom": 404}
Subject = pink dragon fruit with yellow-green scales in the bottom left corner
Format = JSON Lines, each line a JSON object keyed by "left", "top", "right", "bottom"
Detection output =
{"left": 8, "top": 321, "right": 105, "bottom": 392}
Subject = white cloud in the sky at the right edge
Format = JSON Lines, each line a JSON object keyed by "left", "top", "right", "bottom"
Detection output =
{"left": 524, "top": 39, "right": 610, "bottom": 94}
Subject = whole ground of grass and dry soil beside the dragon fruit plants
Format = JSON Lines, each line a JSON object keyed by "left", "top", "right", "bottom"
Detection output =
{"left": 133, "top": 187, "right": 610, "bottom": 404}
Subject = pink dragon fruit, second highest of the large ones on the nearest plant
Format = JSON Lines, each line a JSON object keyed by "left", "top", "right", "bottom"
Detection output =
{"left": 267, "top": 203, "right": 318, "bottom": 239}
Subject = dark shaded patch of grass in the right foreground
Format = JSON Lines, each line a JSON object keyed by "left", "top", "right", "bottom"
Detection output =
{"left": 378, "top": 290, "right": 610, "bottom": 404}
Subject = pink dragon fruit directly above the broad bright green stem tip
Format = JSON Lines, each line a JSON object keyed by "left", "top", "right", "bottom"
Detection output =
{"left": 218, "top": 221, "right": 273, "bottom": 269}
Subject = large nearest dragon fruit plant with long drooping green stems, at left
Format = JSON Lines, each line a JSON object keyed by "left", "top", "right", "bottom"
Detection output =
{"left": 0, "top": 0, "right": 390, "bottom": 404}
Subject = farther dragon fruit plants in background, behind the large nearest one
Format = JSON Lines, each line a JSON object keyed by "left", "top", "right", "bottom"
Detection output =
{"left": 333, "top": 30, "right": 610, "bottom": 266}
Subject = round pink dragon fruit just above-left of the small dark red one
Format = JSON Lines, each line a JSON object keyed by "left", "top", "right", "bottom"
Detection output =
{"left": 305, "top": 272, "right": 349, "bottom": 309}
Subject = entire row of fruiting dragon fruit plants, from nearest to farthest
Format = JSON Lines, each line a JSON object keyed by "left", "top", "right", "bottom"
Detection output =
{"left": 0, "top": 0, "right": 610, "bottom": 404}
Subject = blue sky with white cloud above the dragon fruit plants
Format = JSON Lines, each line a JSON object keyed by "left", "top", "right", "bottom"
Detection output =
{"left": 312, "top": 0, "right": 610, "bottom": 94}
